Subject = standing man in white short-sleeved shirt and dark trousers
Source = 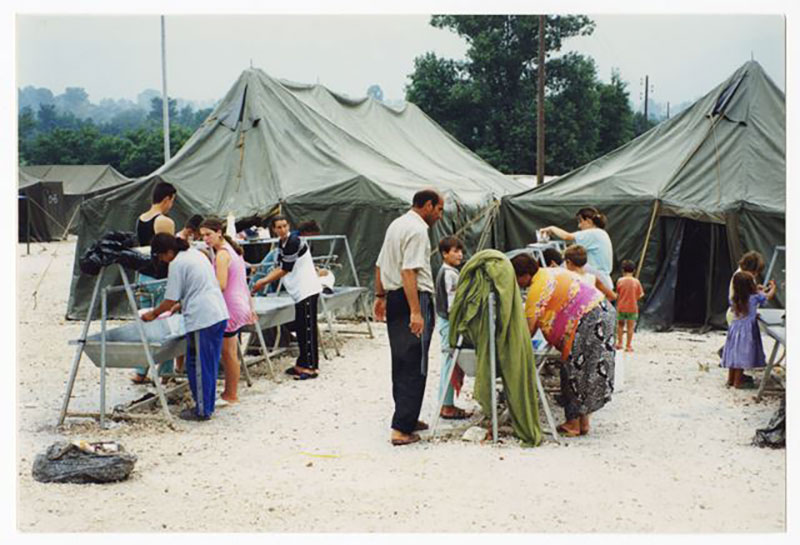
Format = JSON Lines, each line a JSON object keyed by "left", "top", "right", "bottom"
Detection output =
{"left": 374, "top": 189, "right": 444, "bottom": 445}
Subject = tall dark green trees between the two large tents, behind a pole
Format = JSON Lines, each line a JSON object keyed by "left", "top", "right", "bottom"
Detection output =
{"left": 406, "top": 15, "right": 632, "bottom": 174}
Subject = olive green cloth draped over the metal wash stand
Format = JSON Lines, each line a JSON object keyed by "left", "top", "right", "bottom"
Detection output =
{"left": 450, "top": 250, "right": 542, "bottom": 446}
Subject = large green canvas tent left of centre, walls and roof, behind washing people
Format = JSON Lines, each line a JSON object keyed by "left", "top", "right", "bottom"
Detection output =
{"left": 68, "top": 69, "right": 525, "bottom": 318}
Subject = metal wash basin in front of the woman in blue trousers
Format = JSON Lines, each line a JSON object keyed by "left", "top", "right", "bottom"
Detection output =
{"left": 69, "top": 314, "right": 186, "bottom": 367}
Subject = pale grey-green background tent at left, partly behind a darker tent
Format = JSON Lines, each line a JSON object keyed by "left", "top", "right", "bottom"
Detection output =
{"left": 19, "top": 165, "right": 131, "bottom": 238}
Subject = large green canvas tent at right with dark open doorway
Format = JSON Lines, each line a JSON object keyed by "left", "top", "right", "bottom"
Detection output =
{"left": 496, "top": 61, "right": 786, "bottom": 328}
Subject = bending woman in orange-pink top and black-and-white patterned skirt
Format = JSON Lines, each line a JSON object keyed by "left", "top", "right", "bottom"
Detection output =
{"left": 511, "top": 254, "right": 616, "bottom": 437}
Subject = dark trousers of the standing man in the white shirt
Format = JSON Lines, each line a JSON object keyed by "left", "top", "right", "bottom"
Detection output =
{"left": 386, "top": 289, "right": 434, "bottom": 433}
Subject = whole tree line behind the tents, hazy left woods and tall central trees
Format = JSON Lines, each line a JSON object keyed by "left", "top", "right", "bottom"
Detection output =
{"left": 19, "top": 15, "right": 656, "bottom": 177}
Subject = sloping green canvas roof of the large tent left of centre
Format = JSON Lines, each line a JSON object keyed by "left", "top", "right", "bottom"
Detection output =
{"left": 140, "top": 69, "right": 524, "bottom": 217}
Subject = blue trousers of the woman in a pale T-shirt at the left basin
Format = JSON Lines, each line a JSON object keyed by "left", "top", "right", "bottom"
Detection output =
{"left": 186, "top": 320, "right": 228, "bottom": 416}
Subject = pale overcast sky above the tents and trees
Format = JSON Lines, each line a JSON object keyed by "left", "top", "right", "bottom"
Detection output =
{"left": 16, "top": 14, "right": 785, "bottom": 107}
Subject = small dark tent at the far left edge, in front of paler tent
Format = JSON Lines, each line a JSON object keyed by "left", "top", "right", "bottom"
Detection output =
{"left": 17, "top": 170, "right": 69, "bottom": 242}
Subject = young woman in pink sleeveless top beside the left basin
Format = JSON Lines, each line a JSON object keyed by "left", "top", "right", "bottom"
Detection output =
{"left": 200, "top": 219, "right": 255, "bottom": 403}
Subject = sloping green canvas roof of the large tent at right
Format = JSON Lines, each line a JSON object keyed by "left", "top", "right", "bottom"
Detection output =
{"left": 508, "top": 61, "right": 786, "bottom": 222}
